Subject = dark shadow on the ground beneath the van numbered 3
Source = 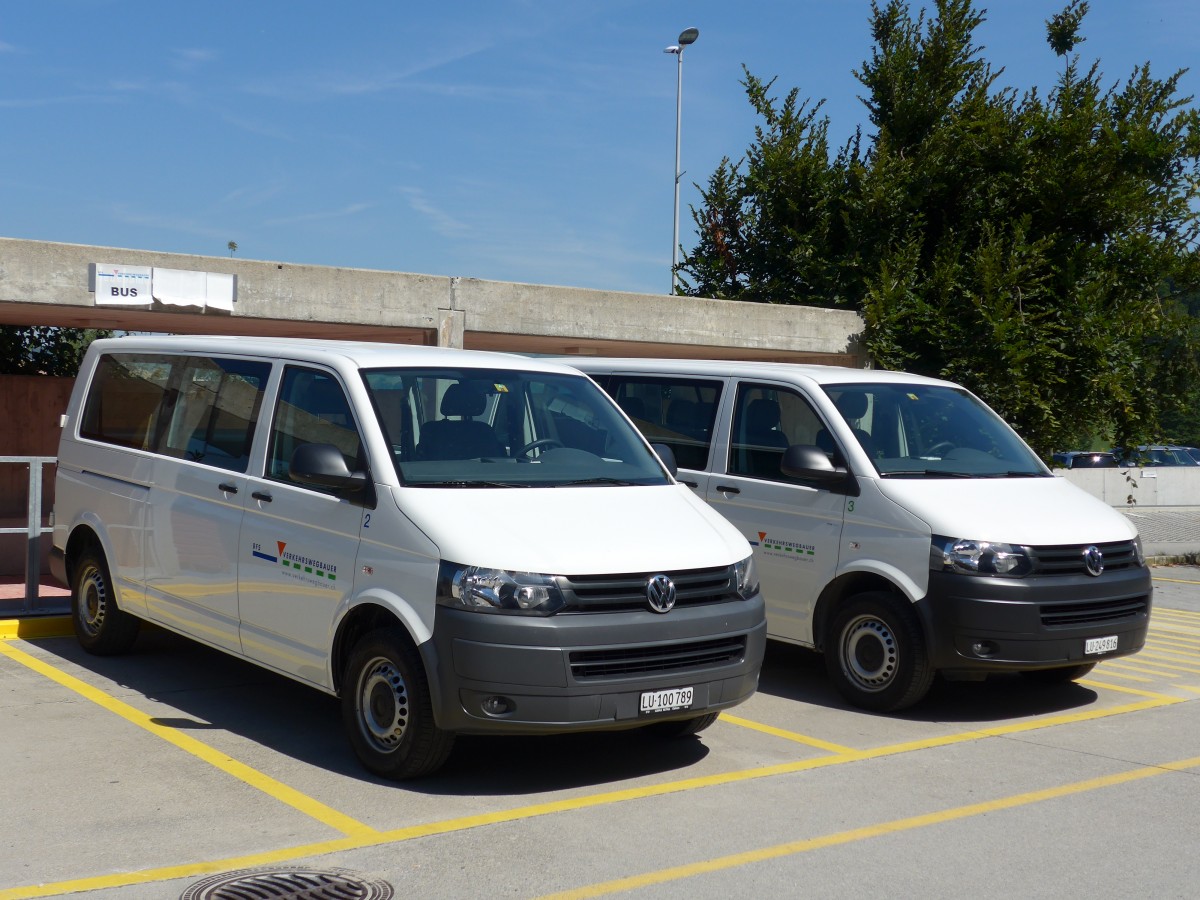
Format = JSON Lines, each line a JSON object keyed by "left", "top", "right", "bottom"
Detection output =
{"left": 758, "top": 641, "right": 1099, "bottom": 725}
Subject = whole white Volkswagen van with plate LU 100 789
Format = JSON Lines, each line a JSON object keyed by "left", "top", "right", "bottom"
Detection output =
{"left": 52, "top": 337, "right": 766, "bottom": 778}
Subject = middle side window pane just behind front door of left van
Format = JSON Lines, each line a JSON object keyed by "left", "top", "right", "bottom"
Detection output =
{"left": 158, "top": 356, "right": 271, "bottom": 472}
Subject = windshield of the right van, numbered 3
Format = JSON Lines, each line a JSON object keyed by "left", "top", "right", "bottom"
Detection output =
{"left": 823, "top": 384, "right": 1052, "bottom": 478}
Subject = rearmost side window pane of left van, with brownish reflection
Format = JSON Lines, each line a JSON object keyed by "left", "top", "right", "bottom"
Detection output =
{"left": 79, "top": 353, "right": 172, "bottom": 450}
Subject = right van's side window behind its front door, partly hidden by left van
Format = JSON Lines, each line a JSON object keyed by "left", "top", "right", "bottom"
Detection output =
{"left": 605, "top": 376, "right": 721, "bottom": 469}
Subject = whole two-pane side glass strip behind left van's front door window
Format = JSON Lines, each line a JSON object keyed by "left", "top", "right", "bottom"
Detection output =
{"left": 79, "top": 354, "right": 271, "bottom": 472}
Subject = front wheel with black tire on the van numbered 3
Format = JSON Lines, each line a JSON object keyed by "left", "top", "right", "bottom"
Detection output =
{"left": 824, "top": 590, "right": 934, "bottom": 713}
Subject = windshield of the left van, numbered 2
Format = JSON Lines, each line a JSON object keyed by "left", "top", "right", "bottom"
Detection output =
{"left": 362, "top": 368, "right": 670, "bottom": 487}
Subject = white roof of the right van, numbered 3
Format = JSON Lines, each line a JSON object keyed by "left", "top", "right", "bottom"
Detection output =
{"left": 556, "top": 356, "right": 959, "bottom": 388}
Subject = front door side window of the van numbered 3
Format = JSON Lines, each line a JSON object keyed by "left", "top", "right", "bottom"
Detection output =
{"left": 728, "top": 383, "right": 834, "bottom": 481}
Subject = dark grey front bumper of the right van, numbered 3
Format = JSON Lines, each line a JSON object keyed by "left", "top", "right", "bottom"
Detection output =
{"left": 917, "top": 568, "right": 1153, "bottom": 671}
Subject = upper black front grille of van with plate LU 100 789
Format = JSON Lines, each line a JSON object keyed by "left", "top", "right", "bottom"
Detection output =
{"left": 558, "top": 565, "right": 738, "bottom": 612}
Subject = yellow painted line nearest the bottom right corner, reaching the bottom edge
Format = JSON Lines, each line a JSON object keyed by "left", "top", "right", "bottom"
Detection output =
{"left": 544, "top": 757, "right": 1200, "bottom": 900}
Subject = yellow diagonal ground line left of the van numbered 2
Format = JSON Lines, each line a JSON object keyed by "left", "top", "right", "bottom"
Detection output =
{"left": 0, "top": 643, "right": 377, "bottom": 836}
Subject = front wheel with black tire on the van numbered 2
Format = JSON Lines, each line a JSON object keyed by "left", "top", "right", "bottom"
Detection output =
{"left": 341, "top": 626, "right": 454, "bottom": 781}
